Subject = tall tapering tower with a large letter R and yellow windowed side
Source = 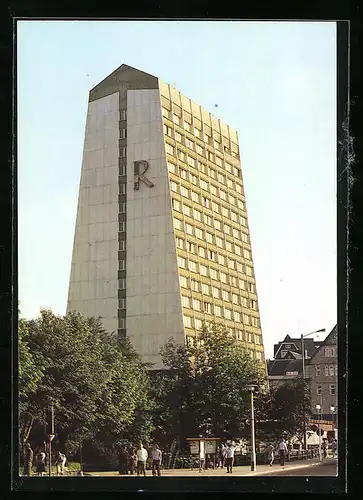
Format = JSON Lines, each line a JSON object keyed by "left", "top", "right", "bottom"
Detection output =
{"left": 67, "top": 65, "right": 264, "bottom": 369}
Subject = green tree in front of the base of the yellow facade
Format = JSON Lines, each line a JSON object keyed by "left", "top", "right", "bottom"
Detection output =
{"left": 154, "top": 324, "right": 264, "bottom": 450}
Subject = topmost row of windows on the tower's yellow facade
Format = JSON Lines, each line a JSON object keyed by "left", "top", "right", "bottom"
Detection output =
{"left": 162, "top": 104, "right": 239, "bottom": 158}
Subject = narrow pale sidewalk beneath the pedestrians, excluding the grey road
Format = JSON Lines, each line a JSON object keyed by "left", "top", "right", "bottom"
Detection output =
{"left": 90, "top": 458, "right": 329, "bottom": 478}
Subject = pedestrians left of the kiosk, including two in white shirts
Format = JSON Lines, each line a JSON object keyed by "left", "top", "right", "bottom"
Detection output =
{"left": 119, "top": 443, "right": 162, "bottom": 477}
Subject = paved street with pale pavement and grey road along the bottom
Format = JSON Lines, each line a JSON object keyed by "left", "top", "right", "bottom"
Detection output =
{"left": 91, "top": 459, "right": 336, "bottom": 478}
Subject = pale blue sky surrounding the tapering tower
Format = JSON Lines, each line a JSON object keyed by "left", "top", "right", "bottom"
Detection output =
{"left": 18, "top": 21, "right": 337, "bottom": 356}
